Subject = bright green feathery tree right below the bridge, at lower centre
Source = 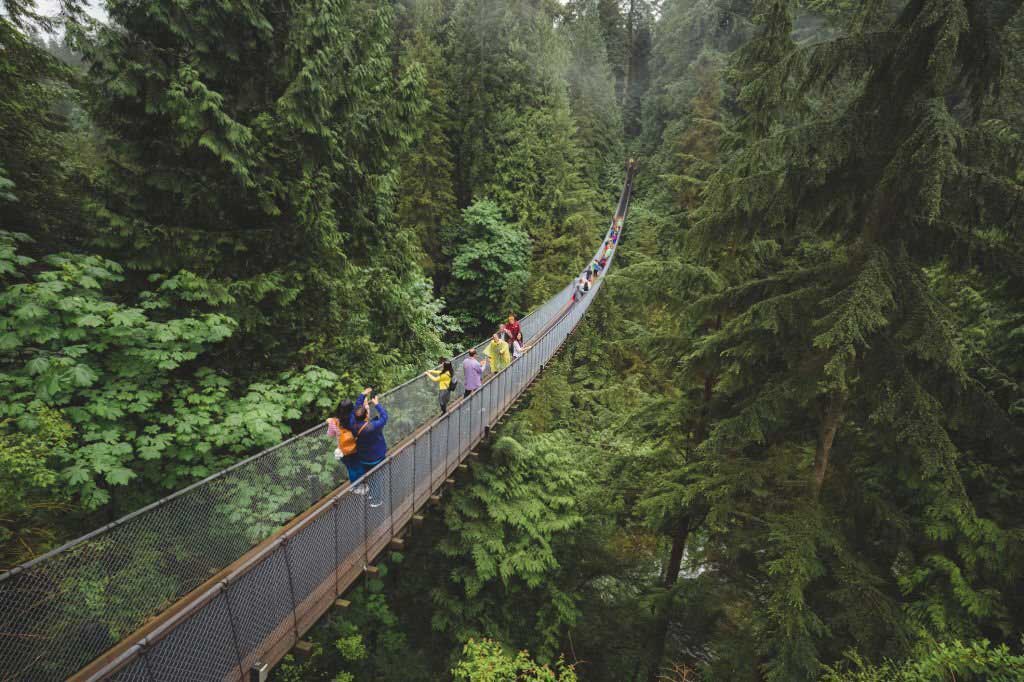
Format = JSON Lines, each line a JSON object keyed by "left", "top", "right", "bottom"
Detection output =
{"left": 432, "top": 433, "right": 582, "bottom": 660}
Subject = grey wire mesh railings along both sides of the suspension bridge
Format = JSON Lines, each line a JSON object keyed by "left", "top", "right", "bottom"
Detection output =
{"left": 0, "top": 165, "right": 632, "bottom": 681}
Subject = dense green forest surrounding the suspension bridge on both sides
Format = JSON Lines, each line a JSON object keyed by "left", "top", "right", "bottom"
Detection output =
{"left": 0, "top": 0, "right": 1024, "bottom": 682}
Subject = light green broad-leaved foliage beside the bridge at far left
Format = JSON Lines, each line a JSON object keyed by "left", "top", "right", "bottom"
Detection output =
{"left": 0, "top": 232, "right": 338, "bottom": 518}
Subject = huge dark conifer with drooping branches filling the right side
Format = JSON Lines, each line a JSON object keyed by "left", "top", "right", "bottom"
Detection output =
{"left": 687, "top": 0, "right": 1024, "bottom": 680}
